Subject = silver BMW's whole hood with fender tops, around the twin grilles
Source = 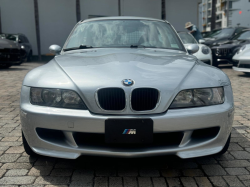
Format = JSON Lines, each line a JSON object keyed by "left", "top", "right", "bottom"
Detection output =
{"left": 23, "top": 49, "right": 230, "bottom": 114}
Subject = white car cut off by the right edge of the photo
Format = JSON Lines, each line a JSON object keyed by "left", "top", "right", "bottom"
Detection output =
{"left": 233, "top": 44, "right": 250, "bottom": 75}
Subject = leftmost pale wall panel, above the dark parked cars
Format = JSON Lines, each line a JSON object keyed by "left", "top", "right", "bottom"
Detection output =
{"left": 0, "top": 0, "right": 37, "bottom": 54}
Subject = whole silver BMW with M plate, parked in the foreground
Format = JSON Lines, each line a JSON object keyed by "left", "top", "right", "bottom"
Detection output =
{"left": 20, "top": 17, "right": 234, "bottom": 159}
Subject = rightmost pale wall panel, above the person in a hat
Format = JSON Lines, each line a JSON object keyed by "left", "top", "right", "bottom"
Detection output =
{"left": 166, "top": 0, "right": 202, "bottom": 31}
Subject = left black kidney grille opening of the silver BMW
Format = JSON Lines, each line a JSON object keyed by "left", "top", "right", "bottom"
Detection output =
{"left": 97, "top": 88, "right": 126, "bottom": 111}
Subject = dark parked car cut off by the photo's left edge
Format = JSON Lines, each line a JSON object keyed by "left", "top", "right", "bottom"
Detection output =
{"left": 0, "top": 38, "right": 20, "bottom": 68}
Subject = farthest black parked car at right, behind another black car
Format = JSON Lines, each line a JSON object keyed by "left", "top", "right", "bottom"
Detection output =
{"left": 202, "top": 27, "right": 247, "bottom": 47}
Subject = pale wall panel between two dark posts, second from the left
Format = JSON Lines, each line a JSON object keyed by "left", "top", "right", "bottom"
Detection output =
{"left": 38, "top": 0, "right": 77, "bottom": 54}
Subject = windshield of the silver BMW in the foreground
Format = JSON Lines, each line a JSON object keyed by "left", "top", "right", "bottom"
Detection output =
{"left": 65, "top": 20, "right": 185, "bottom": 51}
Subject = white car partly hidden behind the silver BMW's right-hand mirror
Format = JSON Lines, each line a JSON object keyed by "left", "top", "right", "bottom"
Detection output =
{"left": 178, "top": 32, "right": 213, "bottom": 65}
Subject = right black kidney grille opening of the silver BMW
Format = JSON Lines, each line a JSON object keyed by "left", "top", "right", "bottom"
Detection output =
{"left": 131, "top": 88, "right": 159, "bottom": 111}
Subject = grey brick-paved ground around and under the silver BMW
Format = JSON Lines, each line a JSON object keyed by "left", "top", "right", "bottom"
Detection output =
{"left": 0, "top": 63, "right": 250, "bottom": 187}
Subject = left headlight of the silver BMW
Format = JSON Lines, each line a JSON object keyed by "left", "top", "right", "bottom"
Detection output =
{"left": 30, "top": 88, "right": 87, "bottom": 110}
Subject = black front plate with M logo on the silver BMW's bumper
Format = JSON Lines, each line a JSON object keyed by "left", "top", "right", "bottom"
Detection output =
{"left": 105, "top": 119, "right": 153, "bottom": 144}
